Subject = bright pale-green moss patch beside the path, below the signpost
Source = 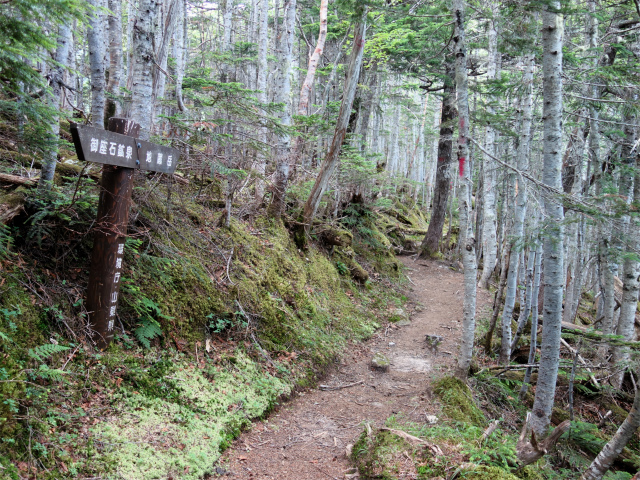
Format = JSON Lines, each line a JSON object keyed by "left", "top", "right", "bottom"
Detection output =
{"left": 90, "top": 350, "right": 291, "bottom": 480}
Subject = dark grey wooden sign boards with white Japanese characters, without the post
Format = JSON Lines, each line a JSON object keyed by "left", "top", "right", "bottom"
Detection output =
{"left": 71, "top": 125, "right": 180, "bottom": 174}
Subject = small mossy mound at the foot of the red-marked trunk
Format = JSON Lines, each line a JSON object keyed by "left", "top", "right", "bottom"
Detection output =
{"left": 433, "top": 377, "right": 487, "bottom": 427}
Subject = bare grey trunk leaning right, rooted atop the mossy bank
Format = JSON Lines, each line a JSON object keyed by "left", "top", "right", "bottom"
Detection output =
{"left": 304, "top": 7, "right": 368, "bottom": 231}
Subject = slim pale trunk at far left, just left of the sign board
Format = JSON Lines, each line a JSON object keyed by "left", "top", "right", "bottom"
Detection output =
{"left": 38, "top": 23, "right": 72, "bottom": 190}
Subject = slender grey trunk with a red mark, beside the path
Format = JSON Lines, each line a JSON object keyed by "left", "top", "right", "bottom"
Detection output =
{"left": 453, "top": 0, "right": 478, "bottom": 379}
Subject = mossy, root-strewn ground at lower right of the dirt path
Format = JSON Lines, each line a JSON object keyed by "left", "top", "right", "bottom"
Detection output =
{"left": 351, "top": 375, "right": 640, "bottom": 480}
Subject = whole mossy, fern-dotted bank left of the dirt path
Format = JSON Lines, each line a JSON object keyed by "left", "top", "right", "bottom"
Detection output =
{"left": 0, "top": 162, "right": 426, "bottom": 480}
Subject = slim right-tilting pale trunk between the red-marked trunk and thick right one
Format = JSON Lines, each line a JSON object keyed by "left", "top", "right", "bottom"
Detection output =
{"left": 498, "top": 55, "right": 535, "bottom": 364}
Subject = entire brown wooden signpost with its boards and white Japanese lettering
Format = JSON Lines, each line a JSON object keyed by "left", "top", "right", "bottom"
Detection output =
{"left": 71, "top": 118, "right": 180, "bottom": 350}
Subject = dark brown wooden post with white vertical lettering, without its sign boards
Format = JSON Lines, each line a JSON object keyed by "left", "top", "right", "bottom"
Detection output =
{"left": 87, "top": 118, "right": 140, "bottom": 350}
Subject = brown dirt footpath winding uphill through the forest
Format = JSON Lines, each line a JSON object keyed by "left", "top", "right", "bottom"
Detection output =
{"left": 217, "top": 257, "right": 491, "bottom": 480}
